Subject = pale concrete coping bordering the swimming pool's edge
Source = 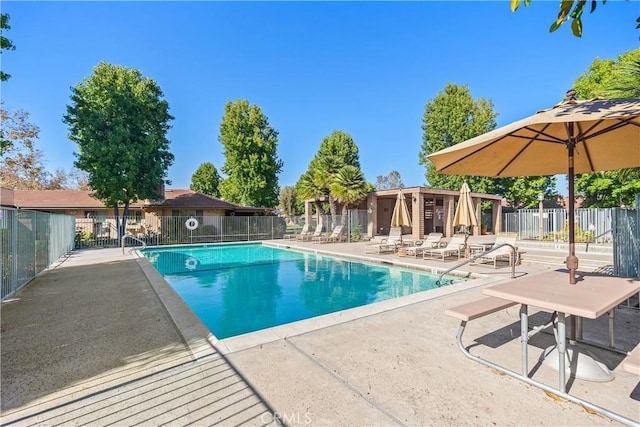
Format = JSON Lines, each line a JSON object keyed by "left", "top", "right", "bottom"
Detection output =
{"left": 135, "top": 242, "right": 509, "bottom": 359}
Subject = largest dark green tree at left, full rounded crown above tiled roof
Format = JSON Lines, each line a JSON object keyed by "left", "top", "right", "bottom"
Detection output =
{"left": 63, "top": 62, "right": 174, "bottom": 239}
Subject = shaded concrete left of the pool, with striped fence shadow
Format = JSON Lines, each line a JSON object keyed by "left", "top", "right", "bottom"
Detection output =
{"left": 0, "top": 257, "right": 277, "bottom": 425}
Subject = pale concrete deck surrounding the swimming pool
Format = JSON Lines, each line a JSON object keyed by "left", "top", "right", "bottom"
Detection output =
{"left": 0, "top": 241, "right": 640, "bottom": 426}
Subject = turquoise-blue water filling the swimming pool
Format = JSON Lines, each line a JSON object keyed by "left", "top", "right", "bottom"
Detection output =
{"left": 142, "top": 244, "right": 463, "bottom": 339}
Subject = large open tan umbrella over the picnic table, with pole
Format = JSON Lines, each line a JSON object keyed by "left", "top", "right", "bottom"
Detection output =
{"left": 428, "top": 95, "right": 640, "bottom": 284}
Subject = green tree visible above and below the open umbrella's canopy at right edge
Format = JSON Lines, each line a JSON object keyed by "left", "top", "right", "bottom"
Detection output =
{"left": 573, "top": 48, "right": 640, "bottom": 207}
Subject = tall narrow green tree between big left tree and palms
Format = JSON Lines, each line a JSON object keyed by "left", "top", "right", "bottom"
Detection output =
{"left": 218, "top": 99, "right": 283, "bottom": 207}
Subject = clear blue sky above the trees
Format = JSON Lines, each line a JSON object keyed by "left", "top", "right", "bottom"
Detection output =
{"left": 1, "top": 0, "right": 640, "bottom": 194}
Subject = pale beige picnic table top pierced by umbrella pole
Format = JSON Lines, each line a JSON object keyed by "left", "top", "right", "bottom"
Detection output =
{"left": 482, "top": 269, "right": 640, "bottom": 319}
